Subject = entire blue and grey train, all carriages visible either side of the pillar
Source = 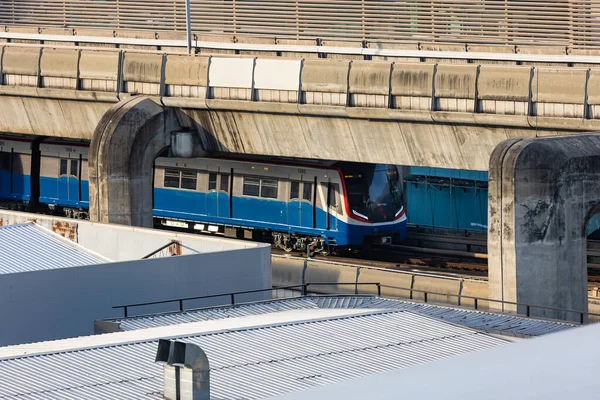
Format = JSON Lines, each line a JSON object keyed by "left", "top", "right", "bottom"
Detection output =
{"left": 0, "top": 137, "right": 407, "bottom": 253}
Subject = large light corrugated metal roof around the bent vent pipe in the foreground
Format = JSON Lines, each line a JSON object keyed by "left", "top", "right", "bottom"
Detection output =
{"left": 0, "top": 310, "right": 507, "bottom": 400}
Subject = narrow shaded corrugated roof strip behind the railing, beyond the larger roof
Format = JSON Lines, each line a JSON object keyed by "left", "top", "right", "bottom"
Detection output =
{"left": 109, "top": 296, "right": 577, "bottom": 337}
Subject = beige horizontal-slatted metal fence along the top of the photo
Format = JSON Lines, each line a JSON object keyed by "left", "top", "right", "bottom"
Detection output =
{"left": 0, "top": 0, "right": 600, "bottom": 48}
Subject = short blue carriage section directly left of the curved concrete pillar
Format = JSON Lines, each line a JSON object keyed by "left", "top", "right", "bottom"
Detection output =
{"left": 39, "top": 142, "right": 89, "bottom": 218}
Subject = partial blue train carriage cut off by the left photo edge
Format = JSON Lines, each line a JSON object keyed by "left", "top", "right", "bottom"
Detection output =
{"left": 0, "top": 136, "right": 31, "bottom": 203}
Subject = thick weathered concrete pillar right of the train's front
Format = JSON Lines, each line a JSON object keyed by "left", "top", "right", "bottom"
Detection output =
{"left": 488, "top": 134, "right": 600, "bottom": 320}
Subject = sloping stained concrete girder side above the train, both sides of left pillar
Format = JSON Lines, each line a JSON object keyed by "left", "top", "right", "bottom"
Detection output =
{"left": 0, "top": 96, "right": 584, "bottom": 171}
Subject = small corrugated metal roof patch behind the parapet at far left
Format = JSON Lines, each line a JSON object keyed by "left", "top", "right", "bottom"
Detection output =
{"left": 0, "top": 222, "right": 108, "bottom": 274}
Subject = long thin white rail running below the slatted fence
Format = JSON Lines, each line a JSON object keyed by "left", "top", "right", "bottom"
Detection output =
{"left": 5, "top": 32, "right": 600, "bottom": 64}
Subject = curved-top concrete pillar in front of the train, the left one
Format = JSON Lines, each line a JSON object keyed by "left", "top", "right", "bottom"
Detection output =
{"left": 89, "top": 97, "right": 179, "bottom": 227}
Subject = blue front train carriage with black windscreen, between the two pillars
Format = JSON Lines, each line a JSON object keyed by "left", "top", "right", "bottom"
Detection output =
{"left": 154, "top": 158, "right": 406, "bottom": 252}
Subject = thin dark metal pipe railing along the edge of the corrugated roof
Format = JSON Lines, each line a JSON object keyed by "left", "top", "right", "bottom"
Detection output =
{"left": 112, "top": 282, "right": 600, "bottom": 325}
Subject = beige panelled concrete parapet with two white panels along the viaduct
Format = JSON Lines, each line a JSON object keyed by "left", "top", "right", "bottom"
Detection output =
{"left": 0, "top": 44, "right": 600, "bottom": 125}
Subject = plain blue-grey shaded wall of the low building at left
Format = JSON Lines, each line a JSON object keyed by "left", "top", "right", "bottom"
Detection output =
{"left": 0, "top": 247, "right": 271, "bottom": 346}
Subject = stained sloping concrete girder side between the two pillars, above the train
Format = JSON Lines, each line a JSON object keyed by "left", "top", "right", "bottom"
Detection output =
{"left": 178, "top": 109, "right": 566, "bottom": 170}
